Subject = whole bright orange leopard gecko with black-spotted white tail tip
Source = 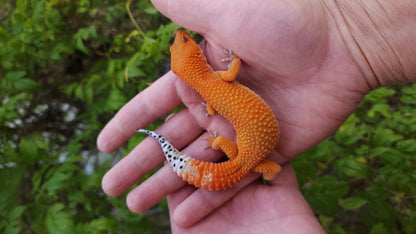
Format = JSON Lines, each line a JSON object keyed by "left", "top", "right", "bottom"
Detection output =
{"left": 137, "top": 31, "right": 280, "bottom": 190}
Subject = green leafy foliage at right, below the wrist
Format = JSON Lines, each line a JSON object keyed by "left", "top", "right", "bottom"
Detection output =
{"left": 292, "top": 84, "right": 416, "bottom": 233}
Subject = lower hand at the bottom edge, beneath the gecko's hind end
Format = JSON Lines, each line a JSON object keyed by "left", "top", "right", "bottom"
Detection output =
{"left": 168, "top": 164, "right": 325, "bottom": 233}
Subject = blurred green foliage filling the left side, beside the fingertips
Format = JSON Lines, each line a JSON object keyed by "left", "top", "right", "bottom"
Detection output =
{"left": 0, "top": 0, "right": 178, "bottom": 233}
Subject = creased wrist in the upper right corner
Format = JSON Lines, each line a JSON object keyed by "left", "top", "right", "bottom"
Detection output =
{"left": 325, "top": 0, "right": 416, "bottom": 88}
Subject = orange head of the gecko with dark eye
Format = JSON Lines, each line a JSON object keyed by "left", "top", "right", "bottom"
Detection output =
{"left": 170, "top": 30, "right": 203, "bottom": 74}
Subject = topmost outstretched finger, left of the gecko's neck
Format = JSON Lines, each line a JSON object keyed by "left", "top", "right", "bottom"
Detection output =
{"left": 97, "top": 72, "right": 181, "bottom": 153}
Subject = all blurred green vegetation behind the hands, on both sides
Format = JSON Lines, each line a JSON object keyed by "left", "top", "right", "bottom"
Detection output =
{"left": 0, "top": 0, "right": 416, "bottom": 233}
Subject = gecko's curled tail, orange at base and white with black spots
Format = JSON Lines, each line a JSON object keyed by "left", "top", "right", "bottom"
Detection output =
{"left": 136, "top": 129, "right": 248, "bottom": 191}
